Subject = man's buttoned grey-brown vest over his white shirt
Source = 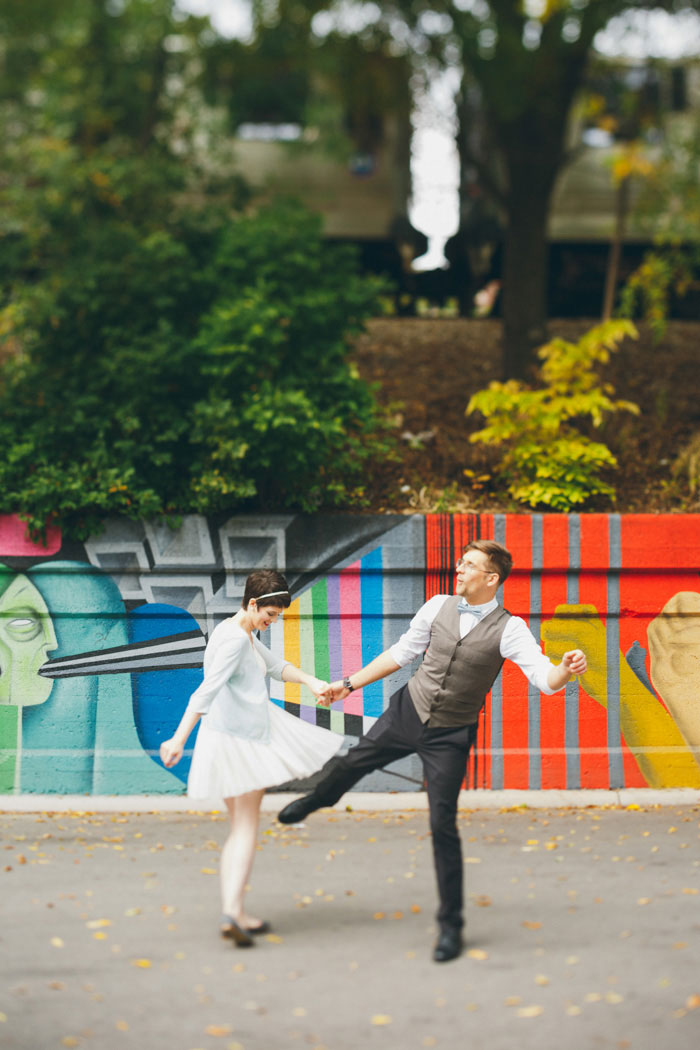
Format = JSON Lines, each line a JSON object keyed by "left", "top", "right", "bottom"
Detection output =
{"left": 408, "top": 597, "right": 510, "bottom": 729}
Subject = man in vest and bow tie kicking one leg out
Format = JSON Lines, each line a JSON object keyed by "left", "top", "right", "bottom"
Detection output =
{"left": 278, "top": 540, "right": 586, "bottom": 963}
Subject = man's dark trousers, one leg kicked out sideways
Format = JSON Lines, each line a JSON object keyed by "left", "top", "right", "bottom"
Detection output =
{"left": 312, "top": 686, "right": 476, "bottom": 927}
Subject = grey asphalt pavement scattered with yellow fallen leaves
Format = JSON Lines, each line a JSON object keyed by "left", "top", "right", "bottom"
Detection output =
{"left": 0, "top": 795, "right": 700, "bottom": 1050}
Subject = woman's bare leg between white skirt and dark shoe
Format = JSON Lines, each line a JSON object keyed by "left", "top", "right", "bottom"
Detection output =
{"left": 220, "top": 791, "right": 264, "bottom": 927}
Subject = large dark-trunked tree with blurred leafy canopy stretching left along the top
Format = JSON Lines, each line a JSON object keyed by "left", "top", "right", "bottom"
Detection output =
{"left": 201, "top": 0, "right": 700, "bottom": 377}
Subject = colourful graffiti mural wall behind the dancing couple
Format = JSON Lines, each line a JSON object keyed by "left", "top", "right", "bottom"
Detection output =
{"left": 0, "top": 515, "right": 700, "bottom": 795}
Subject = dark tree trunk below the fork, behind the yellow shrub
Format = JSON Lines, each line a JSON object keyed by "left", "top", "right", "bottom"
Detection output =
{"left": 502, "top": 169, "right": 551, "bottom": 379}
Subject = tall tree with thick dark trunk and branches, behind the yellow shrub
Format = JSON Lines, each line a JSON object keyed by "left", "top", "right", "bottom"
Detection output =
{"left": 261, "top": 0, "right": 698, "bottom": 377}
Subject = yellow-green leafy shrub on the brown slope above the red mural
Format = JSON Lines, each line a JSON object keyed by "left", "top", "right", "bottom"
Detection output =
{"left": 467, "top": 320, "right": 639, "bottom": 511}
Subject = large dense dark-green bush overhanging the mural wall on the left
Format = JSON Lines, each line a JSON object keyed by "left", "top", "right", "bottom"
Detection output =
{"left": 0, "top": 204, "right": 387, "bottom": 536}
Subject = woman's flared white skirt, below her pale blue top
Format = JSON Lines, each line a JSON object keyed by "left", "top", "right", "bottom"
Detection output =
{"left": 187, "top": 701, "right": 343, "bottom": 799}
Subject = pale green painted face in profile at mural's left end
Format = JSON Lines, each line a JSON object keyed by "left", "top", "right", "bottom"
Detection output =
{"left": 0, "top": 574, "right": 58, "bottom": 708}
